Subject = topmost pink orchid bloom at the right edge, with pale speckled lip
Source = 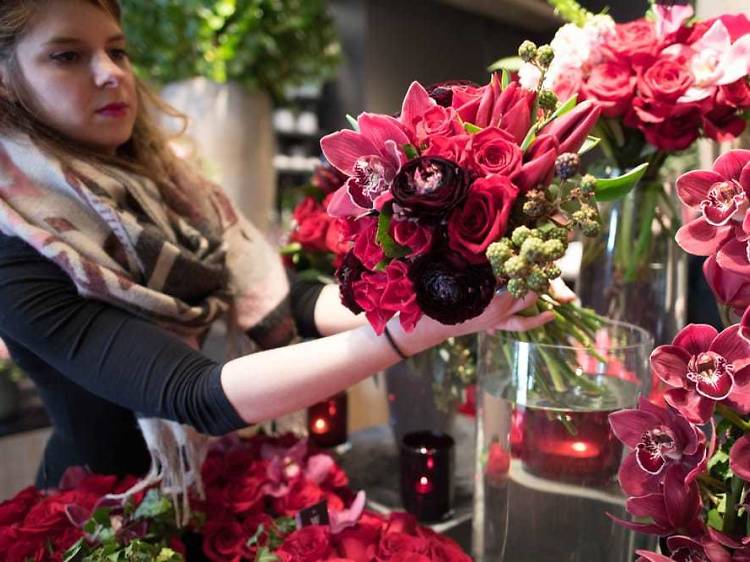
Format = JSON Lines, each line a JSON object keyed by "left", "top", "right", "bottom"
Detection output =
{"left": 676, "top": 150, "right": 750, "bottom": 274}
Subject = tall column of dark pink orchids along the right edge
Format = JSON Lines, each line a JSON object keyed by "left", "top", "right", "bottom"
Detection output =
{"left": 610, "top": 150, "right": 750, "bottom": 562}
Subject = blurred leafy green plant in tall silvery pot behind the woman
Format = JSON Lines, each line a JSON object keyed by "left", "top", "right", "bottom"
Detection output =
{"left": 123, "top": 0, "right": 340, "bottom": 230}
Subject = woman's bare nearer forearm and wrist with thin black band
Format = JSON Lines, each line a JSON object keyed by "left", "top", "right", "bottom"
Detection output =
{"left": 221, "top": 319, "right": 444, "bottom": 423}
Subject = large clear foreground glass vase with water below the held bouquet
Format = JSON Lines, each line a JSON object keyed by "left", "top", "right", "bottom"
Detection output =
{"left": 472, "top": 322, "right": 653, "bottom": 562}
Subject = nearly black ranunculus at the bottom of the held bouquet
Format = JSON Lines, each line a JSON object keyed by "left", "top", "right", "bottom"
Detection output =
{"left": 409, "top": 251, "right": 496, "bottom": 324}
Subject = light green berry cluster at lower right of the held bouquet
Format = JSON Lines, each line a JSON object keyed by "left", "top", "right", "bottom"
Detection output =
{"left": 487, "top": 225, "right": 568, "bottom": 298}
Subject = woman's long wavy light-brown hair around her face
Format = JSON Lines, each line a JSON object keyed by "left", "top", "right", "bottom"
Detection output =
{"left": 0, "top": 0, "right": 186, "bottom": 188}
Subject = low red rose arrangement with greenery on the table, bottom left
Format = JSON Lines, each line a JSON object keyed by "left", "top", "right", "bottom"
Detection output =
{"left": 0, "top": 435, "right": 470, "bottom": 562}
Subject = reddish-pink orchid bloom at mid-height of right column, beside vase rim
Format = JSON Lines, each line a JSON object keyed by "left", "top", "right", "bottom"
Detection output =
{"left": 651, "top": 324, "right": 750, "bottom": 423}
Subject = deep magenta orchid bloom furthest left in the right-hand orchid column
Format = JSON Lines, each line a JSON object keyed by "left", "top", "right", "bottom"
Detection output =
{"left": 609, "top": 398, "right": 707, "bottom": 496}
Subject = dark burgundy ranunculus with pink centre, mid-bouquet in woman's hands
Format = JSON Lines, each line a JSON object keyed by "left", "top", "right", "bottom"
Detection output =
{"left": 391, "top": 156, "right": 469, "bottom": 220}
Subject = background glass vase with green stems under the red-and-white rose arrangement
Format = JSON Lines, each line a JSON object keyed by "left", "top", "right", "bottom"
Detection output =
{"left": 576, "top": 176, "right": 687, "bottom": 345}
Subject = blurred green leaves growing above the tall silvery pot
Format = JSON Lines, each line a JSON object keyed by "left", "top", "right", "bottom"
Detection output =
{"left": 122, "top": 0, "right": 340, "bottom": 98}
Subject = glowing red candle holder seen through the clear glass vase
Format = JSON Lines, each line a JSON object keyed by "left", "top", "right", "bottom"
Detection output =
{"left": 521, "top": 407, "right": 622, "bottom": 484}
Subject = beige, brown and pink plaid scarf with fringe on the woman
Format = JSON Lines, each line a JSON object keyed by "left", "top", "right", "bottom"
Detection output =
{"left": 0, "top": 138, "right": 294, "bottom": 520}
